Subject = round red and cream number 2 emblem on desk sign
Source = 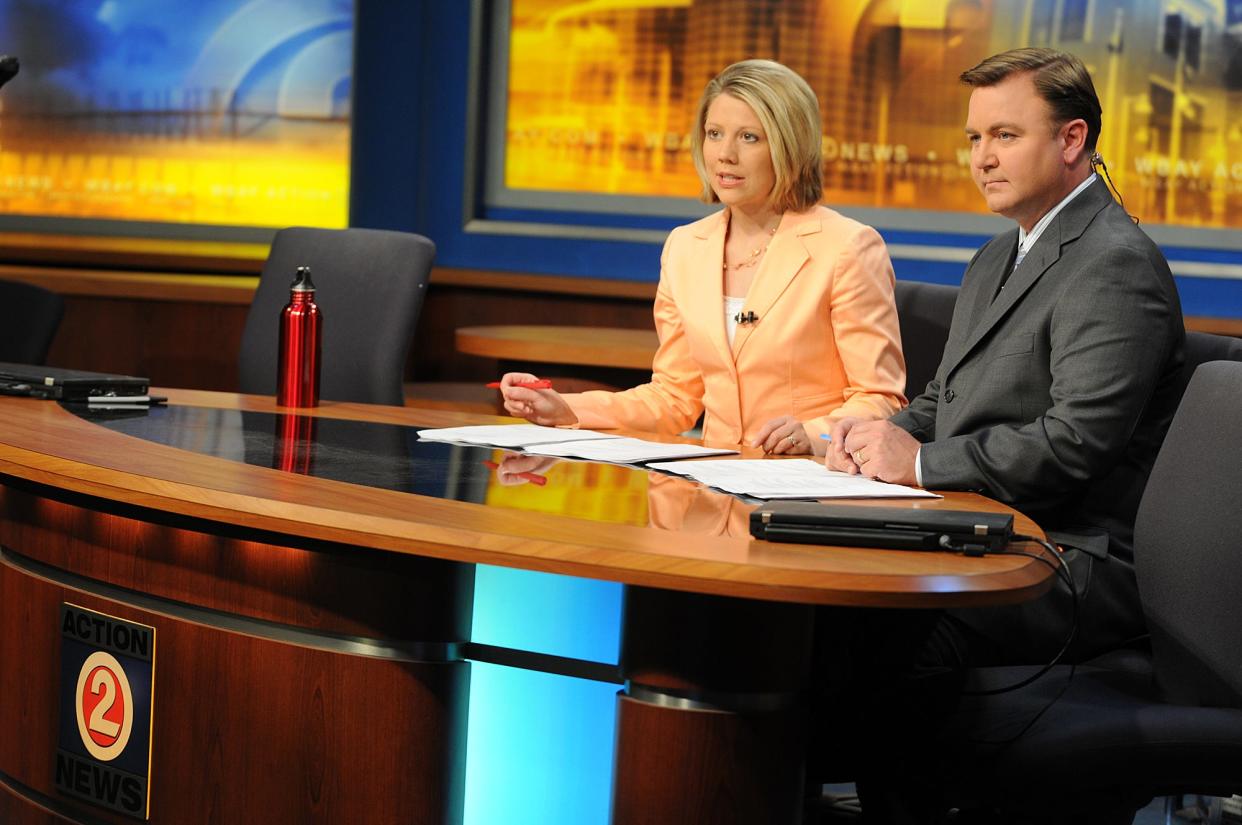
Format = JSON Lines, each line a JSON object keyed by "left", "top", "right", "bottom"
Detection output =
{"left": 73, "top": 650, "right": 134, "bottom": 762}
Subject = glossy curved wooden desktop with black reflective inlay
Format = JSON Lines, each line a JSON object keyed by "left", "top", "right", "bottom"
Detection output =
{"left": 0, "top": 390, "right": 1048, "bottom": 606}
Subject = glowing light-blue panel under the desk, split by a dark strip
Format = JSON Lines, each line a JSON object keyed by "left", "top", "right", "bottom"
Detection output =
{"left": 465, "top": 565, "right": 622, "bottom": 825}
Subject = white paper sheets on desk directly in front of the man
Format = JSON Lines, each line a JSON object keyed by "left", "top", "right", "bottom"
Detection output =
{"left": 647, "top": 458, "right": 940, "bottom": 498}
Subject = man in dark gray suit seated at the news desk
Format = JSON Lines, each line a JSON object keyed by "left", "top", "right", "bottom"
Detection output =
{"left": 827, "top": 48, "right": 1185, "bottom": 665}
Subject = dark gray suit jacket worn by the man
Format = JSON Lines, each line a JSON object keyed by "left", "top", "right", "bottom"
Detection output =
{"left": 892, "top": 180, "right": 1185, "bottom": 656}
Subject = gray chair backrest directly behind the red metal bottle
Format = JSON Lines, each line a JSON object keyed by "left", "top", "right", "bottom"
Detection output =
{"left": 238, "top": 226, "right": 436, "bottom": 405}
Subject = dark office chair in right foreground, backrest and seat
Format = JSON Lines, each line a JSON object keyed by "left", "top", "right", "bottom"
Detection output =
{"left": 908, "top": 362, "right": 1242, "bottom": 825}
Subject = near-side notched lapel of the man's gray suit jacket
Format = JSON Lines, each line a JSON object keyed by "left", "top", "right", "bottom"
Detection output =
{"left": 945, "top": 180, "right": 1112, "bottom": 375}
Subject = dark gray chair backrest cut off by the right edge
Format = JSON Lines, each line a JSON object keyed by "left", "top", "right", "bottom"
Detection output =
{"left": 1134, "top": 362, "right": 1242, "bottom": 707}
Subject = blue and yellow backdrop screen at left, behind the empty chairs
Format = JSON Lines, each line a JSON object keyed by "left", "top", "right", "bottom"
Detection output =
{"left": 0, "top": 0, "right": 354, "bottom": 237}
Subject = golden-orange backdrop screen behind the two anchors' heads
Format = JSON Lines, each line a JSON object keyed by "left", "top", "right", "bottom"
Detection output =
{"left": 487, "top": 0, "right": 1242, "bottom": 235}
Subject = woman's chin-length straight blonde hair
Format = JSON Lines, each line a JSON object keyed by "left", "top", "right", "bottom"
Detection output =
{"left": 691, "top": 60, "right": 823, "bottom": 212}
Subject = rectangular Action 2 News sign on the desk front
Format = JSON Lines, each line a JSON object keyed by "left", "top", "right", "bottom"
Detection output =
{"left": 56, "top": 603, "right": 155, "bottom": 819}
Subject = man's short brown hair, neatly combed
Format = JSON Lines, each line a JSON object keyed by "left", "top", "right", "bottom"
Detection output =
{"left": 961, "top": 48, "right": 1100, "bottom": 153}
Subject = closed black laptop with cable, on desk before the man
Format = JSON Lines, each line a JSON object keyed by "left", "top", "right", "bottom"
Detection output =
{"left": 750, "top": 501, "right": 1013, "bottom": 555}
